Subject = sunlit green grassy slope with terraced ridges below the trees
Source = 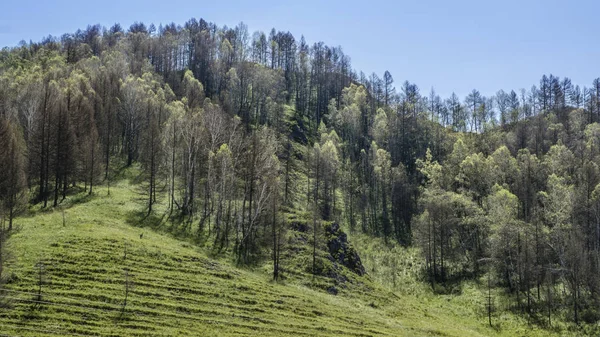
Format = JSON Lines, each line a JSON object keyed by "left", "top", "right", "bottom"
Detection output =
{"left": 0, "top": 169, "right": 572, "bottom": 336}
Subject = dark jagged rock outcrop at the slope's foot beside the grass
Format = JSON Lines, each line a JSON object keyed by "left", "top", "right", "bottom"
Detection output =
{"left": 325, "top": 223, "right": 365, "bottom": 276}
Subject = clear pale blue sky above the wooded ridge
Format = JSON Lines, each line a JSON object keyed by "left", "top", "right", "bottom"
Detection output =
{"left": 0, "top": 0, "right": 600, "bottom": 97}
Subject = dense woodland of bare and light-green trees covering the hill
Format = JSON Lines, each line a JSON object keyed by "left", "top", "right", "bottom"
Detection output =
{"left": 0, "top": 19, "right": 600, "bottom": 325}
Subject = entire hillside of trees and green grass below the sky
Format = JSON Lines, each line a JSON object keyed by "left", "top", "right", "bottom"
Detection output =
{"left": 0, "top": 19, "right": 600, "bottom": 336}
